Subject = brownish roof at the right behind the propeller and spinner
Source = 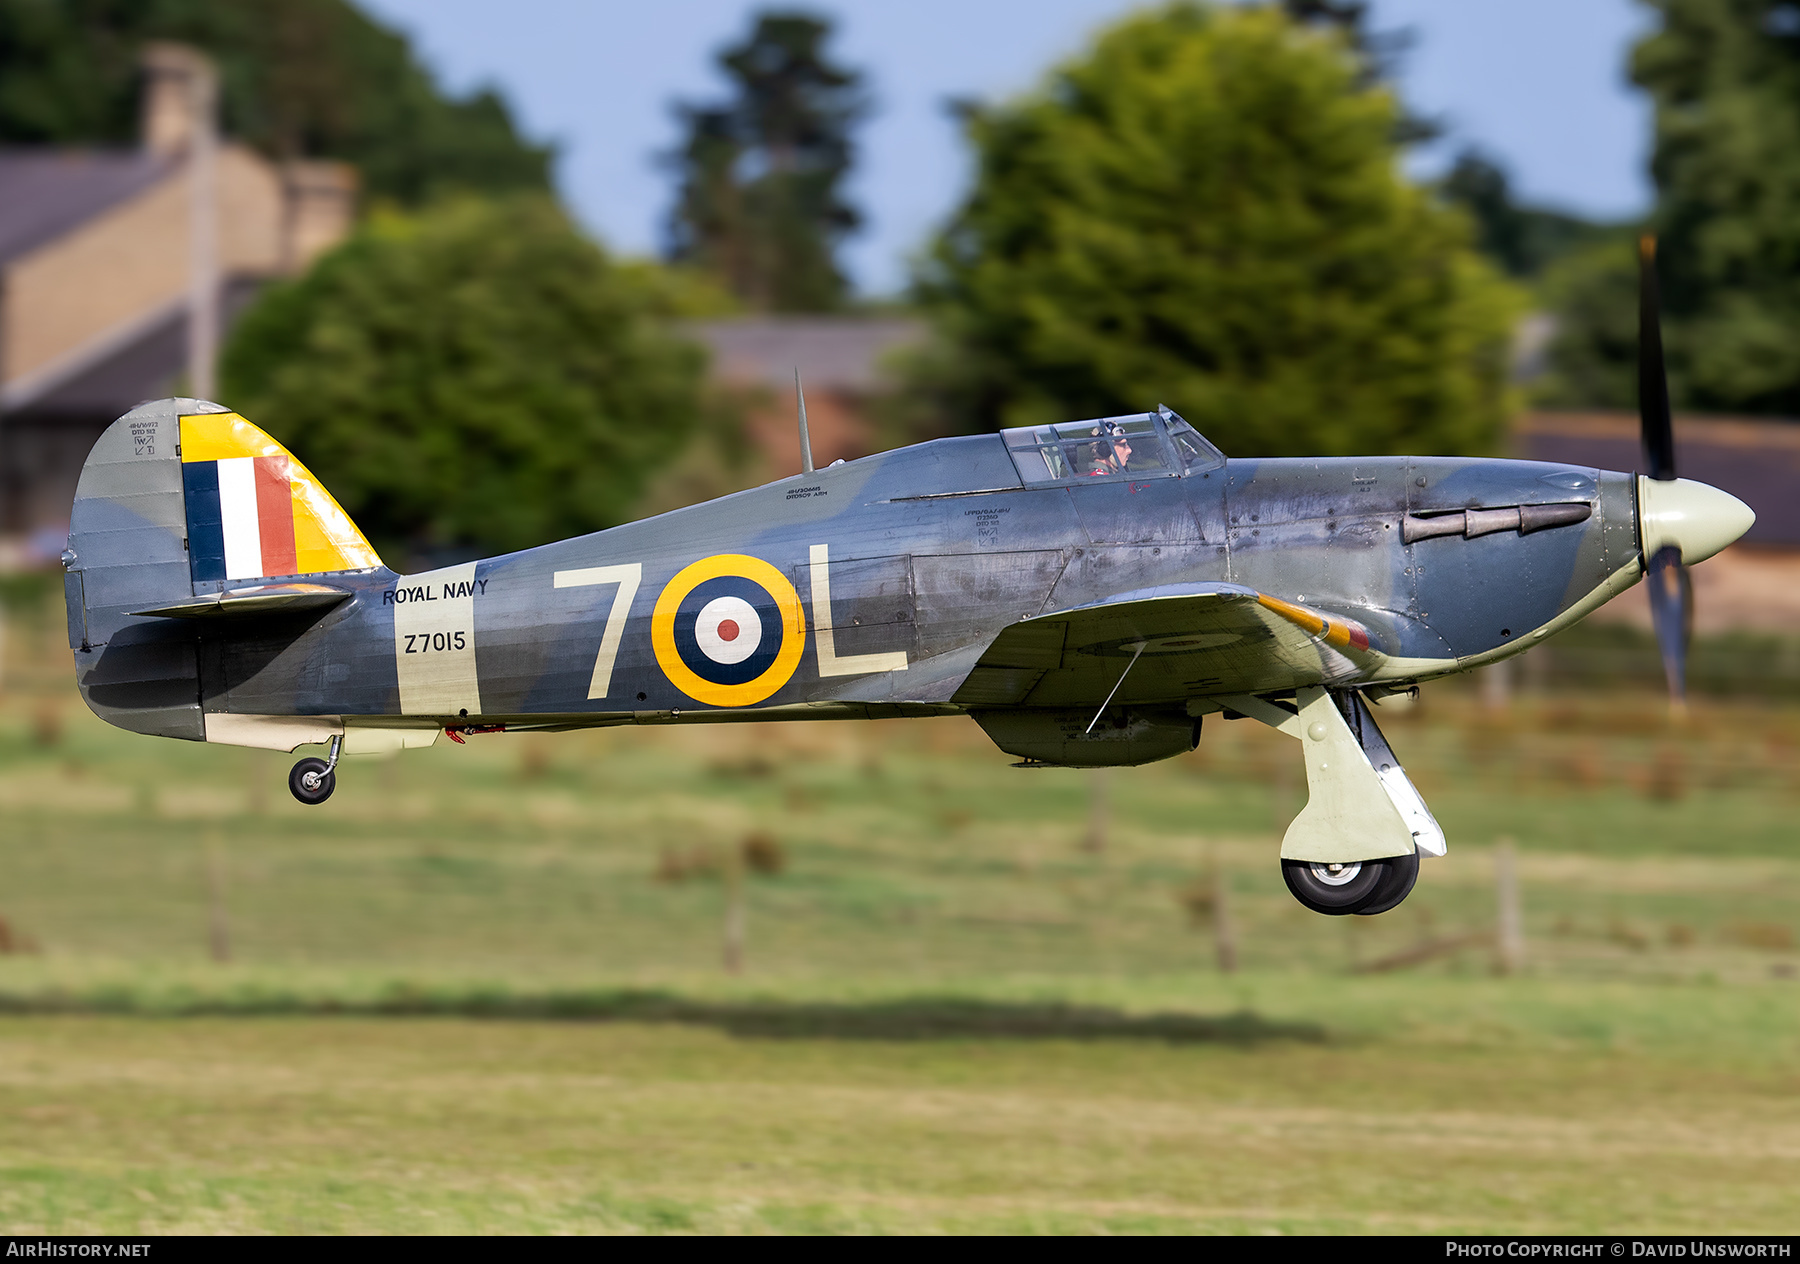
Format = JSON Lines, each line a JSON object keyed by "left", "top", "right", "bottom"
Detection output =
{"left": 1514, "top": 412, "right": 1800, "bottom": 547}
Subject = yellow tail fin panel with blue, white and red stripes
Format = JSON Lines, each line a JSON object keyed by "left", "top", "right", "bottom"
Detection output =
{"left": 182, "top": 412, "right": 382, "bottom": 582}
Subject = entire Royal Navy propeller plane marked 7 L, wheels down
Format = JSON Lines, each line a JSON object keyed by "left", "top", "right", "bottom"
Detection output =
{"left": 63, "top": 244, "right": 1751, "bottom": 913}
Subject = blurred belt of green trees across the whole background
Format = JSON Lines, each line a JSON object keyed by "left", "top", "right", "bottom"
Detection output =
{"left": 0, "top": 0, "right": 1800, "bottom": 532}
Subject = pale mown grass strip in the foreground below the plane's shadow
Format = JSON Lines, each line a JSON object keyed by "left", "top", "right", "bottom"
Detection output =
{"left": 0, "top": 980, "right": 1800, "bottom": 1233}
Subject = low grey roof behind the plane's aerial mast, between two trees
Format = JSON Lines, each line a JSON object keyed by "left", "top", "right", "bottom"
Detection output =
{"left": 688, "top": 317, "right": 925, "bottom": 391}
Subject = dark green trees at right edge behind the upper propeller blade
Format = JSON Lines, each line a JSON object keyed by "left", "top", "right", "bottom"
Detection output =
{"left": 1550, "top": 0, "right": 1800, "bottom": 416}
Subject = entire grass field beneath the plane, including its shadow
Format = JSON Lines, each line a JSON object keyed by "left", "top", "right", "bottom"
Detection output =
{"left": 0, "top": 603, "right": 1800, "bottom": 1233}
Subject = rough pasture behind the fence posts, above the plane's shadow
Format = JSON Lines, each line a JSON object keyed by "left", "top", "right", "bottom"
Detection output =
{"left": 0, "top": 691, "right": 1800, "bottom": 983}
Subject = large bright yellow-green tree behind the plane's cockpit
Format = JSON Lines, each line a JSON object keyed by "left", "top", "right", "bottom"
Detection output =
{"left": 916, "top": 4, "right": 1517, "bottom": 456}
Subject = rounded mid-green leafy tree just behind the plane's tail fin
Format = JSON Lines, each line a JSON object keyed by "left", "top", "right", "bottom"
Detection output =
{"left": 221, "top": 194, "right": 720, "bottom": 549}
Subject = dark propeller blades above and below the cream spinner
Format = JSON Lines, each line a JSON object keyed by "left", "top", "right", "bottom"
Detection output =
{"left": 1638, "top": 234, "right": 1694, "bottom": 709}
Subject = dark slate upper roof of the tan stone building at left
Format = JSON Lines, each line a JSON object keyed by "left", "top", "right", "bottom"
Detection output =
{"left": 0, "top": 149, "right": 173, "bottom": 263}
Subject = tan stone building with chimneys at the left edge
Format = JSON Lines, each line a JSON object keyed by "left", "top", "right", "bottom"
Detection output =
{"left": 0, "top": 45, "right": 356, "bottom": 567}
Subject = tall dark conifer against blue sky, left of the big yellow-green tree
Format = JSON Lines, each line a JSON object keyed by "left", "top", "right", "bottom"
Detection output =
{"left": 670, "top": 13, "right": 866, "bottom": 311}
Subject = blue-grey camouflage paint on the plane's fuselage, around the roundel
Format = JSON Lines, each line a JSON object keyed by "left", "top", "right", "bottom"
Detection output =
{"left": 68, "top": 405, "right": 1638, "bottom": 752}
